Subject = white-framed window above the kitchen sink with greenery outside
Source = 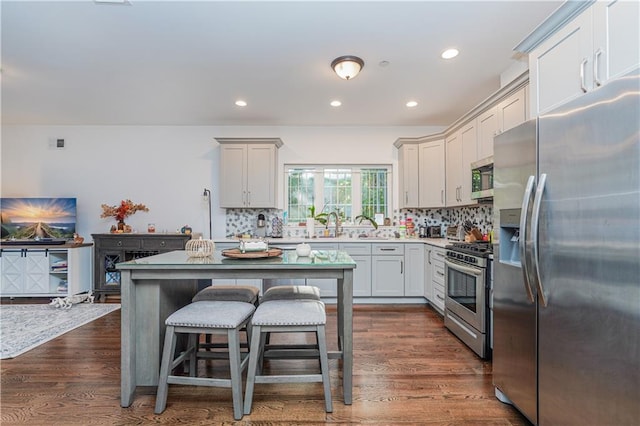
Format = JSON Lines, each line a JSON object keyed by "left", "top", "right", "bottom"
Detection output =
{"left": 285, "top": 165, "right": 391, "bottom": 222}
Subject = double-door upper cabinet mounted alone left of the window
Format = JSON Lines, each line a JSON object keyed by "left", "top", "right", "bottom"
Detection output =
{"left": 216, "top": 138, "right": 282, "bottom": 208}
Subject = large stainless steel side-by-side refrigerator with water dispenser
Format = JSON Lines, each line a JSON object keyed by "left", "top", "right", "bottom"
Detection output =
{"left": 493, "top": 70, "right": 640, "bottom": 426}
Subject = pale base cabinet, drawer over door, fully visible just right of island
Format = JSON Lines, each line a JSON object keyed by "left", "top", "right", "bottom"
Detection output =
{"left": 371, "top": 243, "right": 404, "bottom": 297}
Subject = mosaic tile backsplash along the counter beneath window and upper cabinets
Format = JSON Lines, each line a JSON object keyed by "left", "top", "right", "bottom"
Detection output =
{"left": 226, "top": 204, "right": 493, "bottom": 238}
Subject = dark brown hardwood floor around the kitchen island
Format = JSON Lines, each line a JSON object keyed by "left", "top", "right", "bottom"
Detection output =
{"left": 0, "top": 305, "right": 529, "bottom": 425}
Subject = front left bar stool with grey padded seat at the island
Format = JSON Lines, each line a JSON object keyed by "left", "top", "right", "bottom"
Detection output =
{"left": 155, "top": 301, "right": 256, "bottom": 420}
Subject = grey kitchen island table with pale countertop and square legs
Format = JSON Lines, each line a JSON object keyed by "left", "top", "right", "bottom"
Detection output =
{"left": 117, "top": 251, "right": 356, "bottom": 407}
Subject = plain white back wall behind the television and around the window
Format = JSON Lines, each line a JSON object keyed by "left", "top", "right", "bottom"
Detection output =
{"left": 0, "top": 126, "right": 442, "bottom": 239}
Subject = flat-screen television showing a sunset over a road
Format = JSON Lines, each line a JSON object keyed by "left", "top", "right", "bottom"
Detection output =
{"left": 0, "top": 198, "right": 76, "bottom": 240}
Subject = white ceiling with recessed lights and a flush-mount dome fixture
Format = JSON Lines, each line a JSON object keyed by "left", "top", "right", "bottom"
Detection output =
{"left": 0, "top": 0, "right": 561, "bottom": 126}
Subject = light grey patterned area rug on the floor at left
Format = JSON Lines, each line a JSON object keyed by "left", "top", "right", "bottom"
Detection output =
{"left": 0, "top": 303, "right": 120, "bottom": 359}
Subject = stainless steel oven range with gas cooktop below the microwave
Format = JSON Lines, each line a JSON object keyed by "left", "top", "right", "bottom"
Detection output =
{"left": 444, "top": 242, "right": 492, "bottom": 358}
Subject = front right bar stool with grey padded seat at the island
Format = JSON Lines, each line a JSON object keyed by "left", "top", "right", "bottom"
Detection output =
{"left": 244, "top": 300, "right": 333, "bottom": 414}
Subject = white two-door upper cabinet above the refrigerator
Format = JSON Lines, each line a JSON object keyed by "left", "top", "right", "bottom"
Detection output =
{"left": 529, "top": 0, "right": 640, "bottom": 116}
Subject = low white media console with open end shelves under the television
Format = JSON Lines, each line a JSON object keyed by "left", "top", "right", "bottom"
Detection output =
{"left": 0, "top": 244, "right": 92, "bottom": 297}
